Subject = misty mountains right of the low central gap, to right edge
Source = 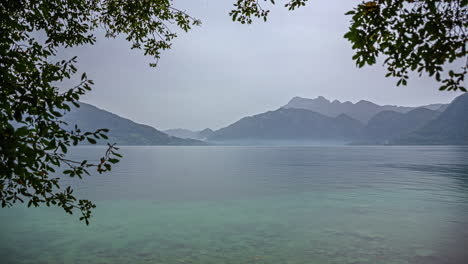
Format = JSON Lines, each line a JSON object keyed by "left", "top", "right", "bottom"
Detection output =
{"left": 204, "top": 94, "right": 468, "bottom": 144}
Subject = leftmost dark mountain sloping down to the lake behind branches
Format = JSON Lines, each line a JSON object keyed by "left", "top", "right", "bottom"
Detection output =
{"left": 63, "top": 103, "right": 205, "bottom": 145}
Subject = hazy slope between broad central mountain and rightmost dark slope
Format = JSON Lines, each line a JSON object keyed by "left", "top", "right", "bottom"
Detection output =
{"left": 363, "top": 108, "right": 440, "bottom": 143}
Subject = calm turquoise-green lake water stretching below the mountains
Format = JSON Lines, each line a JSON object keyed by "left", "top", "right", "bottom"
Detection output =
{"left": 0, "top": 146, "right": 468, "bottom": 264}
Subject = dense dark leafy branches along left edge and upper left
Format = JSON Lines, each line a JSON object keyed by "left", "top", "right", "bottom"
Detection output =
{"left": 0, "top": 0, "right": 200, "bottom": 224}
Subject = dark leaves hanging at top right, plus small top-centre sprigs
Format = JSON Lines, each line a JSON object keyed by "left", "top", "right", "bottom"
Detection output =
{"left": 230, "top": 0, "right": 468, "bottom": 91}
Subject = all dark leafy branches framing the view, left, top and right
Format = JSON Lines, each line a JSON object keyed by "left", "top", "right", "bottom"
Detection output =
{"left": 0, "top": 0, "right": 468, "bottom": 223}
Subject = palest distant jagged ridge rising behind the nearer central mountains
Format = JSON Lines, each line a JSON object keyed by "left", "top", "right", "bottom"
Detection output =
{"left": 284, "top": 96, "right": 444, "bottom": 124}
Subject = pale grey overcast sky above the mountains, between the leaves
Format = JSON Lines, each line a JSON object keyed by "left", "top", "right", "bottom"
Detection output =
{"left": 68, "top": 0, "right": 459, "bottom": 130}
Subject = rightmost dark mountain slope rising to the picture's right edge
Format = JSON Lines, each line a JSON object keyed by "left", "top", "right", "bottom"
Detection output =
{"left": 392, "top": 93, "right": 468, "bottom": 145}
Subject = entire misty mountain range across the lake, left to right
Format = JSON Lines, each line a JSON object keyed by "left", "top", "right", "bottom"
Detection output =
{"left": 63, "top": 94, "right": 468, "bottom": 145}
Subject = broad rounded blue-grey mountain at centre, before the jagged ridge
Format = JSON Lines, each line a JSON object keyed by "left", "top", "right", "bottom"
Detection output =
{"left": 209, "top": 108, "right": 364, "bottom": 141}
